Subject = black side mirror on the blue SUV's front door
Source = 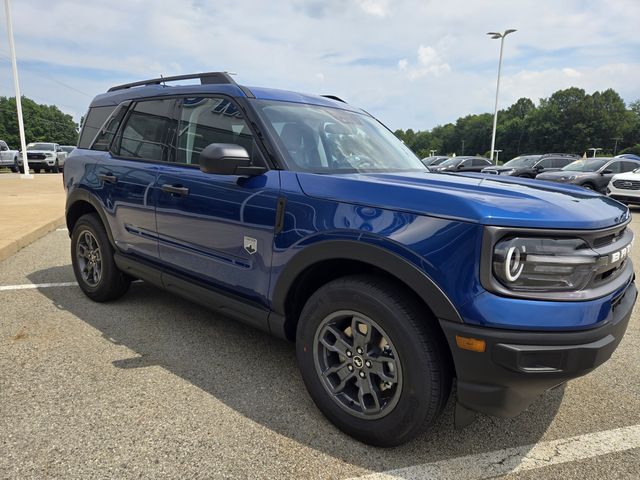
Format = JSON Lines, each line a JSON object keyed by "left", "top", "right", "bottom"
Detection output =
{"left": 200, "top": 143, "right": 267, "bottom": 176}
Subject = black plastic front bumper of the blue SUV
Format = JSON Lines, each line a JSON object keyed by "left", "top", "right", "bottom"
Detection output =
{"left": 440, "top": 282, "right": 638, "bottom": 417}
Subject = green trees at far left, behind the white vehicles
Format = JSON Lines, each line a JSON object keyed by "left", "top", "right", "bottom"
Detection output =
{"left": 0, "top": 96, "right": 78, "bottom": 150}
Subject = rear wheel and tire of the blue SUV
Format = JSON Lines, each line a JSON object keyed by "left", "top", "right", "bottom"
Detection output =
{"left": 71, "top": 213, "right": 131, "bottom": 302}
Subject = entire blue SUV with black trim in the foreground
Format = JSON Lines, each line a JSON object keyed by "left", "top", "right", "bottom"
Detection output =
{"left": 64, "top": 73, "right": 637, "bottom": 446}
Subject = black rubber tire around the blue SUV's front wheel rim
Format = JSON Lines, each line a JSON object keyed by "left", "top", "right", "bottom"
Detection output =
{"left": 296, "top": 285, "right": 439, "bottom": 446}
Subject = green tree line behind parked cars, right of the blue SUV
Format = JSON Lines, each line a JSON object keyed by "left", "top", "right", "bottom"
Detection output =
{"left": 395, "top": 87, "right": 640, "bottom": 161}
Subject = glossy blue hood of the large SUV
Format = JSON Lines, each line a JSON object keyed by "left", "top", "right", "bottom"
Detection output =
{"left": 296, "top": 172, "right": 629, "bottom": 229}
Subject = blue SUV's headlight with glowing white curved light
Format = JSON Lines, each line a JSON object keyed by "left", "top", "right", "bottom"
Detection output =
{"left": 492, "top": 237, "right": 608, "bottom": 292}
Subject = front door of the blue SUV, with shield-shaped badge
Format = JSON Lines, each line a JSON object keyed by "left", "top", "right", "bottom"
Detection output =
{"left": 156, "top": 96, "right": 280, "bottom": 305}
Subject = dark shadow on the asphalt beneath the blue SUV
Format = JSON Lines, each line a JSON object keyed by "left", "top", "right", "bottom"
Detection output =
{"left": 28, "top": 265, "right": 564, "bottom": 471}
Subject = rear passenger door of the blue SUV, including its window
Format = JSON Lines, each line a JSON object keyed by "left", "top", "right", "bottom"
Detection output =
{"left": 94, "top": 98, "right": 176, "bottom": 261}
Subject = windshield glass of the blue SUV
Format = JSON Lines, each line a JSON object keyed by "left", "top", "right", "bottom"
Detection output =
{"left": 254, "top": 100, "right": 428, "bottom": 173}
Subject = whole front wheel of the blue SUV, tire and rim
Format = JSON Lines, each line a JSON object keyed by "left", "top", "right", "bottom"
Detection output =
{"left": 296, "top": 275, "right": 452, "bottom": 447}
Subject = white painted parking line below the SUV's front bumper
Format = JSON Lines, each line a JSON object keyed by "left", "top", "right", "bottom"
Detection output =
{"left": 348, "top": 425, "right": 640, "bottom": 480}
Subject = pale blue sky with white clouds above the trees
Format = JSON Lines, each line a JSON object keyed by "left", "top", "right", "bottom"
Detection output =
{"left": 0, "top": 0, "right": 640, "bottom": 130}
